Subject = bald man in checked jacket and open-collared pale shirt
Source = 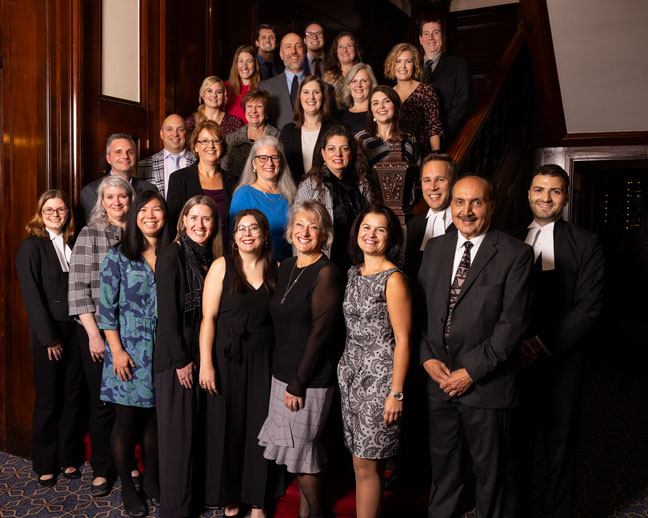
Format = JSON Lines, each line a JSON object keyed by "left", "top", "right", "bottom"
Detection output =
{"left": 137, "top": 113, "right": 196, "bottom": 199}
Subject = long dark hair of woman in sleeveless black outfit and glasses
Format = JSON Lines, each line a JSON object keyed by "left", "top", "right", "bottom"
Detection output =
{"left": 232, "top": 209, "right": 277, "bottom": 293}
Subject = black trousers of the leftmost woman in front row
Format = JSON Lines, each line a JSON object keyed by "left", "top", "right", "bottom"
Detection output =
{"left": 31, "top": 322, "right": 83, "bottom": 475}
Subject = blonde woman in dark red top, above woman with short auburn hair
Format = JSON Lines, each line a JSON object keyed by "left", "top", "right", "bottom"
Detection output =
{"left": 185, "top": 76, "right": 243, "bottom": 135}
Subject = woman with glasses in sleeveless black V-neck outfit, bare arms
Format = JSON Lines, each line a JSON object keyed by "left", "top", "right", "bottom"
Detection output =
{"left": 200, "top": 209, "right": 277, "bottom": 518}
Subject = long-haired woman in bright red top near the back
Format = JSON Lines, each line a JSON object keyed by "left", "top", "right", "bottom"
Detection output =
{"left": 225, "top": 45, "right": 261, "bottom": 124}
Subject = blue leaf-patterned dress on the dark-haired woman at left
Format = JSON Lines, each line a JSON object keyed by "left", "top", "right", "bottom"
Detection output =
{"left": 99, "top": 246, "right": 157, "bottom": 408}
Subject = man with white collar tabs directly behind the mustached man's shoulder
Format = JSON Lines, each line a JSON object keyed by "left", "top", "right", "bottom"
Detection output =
{"left": 405, "top": 153, "right": 457, "bottom": 280}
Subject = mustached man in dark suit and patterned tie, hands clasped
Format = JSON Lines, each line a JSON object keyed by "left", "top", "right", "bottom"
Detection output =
{"left": 418, "top": 176, "right": 533, "bottom": 518}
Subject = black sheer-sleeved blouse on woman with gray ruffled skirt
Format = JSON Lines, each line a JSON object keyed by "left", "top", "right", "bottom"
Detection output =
{"left": 270, "top": 255, "right": 344, "bottom": 397}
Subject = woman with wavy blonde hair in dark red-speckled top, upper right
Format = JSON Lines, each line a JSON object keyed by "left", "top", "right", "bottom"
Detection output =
{"left": 385, "top": 43, "right": 443, "bottom": 155}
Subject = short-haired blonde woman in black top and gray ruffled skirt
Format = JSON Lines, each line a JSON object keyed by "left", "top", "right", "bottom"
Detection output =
{"left": 259, "top": 200, "right": 344, "bottom": 518}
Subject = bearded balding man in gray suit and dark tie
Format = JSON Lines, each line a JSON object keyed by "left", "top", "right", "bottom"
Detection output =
{"left": 259, "top": 32, "right": 306, "bottom": 129}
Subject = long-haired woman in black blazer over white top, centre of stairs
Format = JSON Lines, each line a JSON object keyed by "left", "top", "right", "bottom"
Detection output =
{"left": 279, "top": 76, "right": 334, "bottom": 185}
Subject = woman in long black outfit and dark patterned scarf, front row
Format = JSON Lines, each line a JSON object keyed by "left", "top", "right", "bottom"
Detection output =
{"left": 153, "top": 195, "right": 223, "bottom": 518}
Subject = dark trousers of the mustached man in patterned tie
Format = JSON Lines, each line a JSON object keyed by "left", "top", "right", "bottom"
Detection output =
{"left": 428, "top": 379, "right": 511, "bottom": 518}
